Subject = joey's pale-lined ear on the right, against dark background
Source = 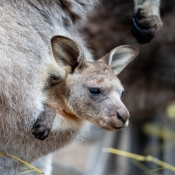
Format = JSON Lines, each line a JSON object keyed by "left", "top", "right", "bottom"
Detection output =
{"left": 99, "top": 45, "right": 139, "bottom": 75}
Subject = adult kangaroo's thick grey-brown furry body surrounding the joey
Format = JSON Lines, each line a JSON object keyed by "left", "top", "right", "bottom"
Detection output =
{"left": 0, "top": 0, "right": 161, "bottom": 175}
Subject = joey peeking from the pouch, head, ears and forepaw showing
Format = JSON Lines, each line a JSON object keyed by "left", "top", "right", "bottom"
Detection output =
{"left": 33, "top": 36, "right": 138, "bottom": 140}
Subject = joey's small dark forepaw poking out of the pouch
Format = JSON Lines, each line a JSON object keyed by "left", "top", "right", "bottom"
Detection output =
{"left": 32, "top": 105, "right": 56, "bottom": 140}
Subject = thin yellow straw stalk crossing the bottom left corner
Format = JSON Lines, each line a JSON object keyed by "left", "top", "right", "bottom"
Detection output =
{"left": 0, "top": 151, "right": 45, "bottom": 175}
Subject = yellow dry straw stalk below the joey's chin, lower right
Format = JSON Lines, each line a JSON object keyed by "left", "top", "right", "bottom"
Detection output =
{"left": 103, "top": 148, "right": 175, "bottom": 172}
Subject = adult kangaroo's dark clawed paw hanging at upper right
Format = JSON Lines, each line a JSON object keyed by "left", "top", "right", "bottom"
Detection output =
{"left": 132, "top": 9, "right": 162, "bottom": 44}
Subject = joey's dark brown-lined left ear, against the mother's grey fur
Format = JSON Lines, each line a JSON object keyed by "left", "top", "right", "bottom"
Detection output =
{"left": 51, "top": 36, "right": 85, "bottom": 72}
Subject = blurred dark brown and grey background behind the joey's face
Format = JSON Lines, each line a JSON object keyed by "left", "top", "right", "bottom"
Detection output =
{"left": 53, "top": 0, "right": 175, "bottom": 175}
